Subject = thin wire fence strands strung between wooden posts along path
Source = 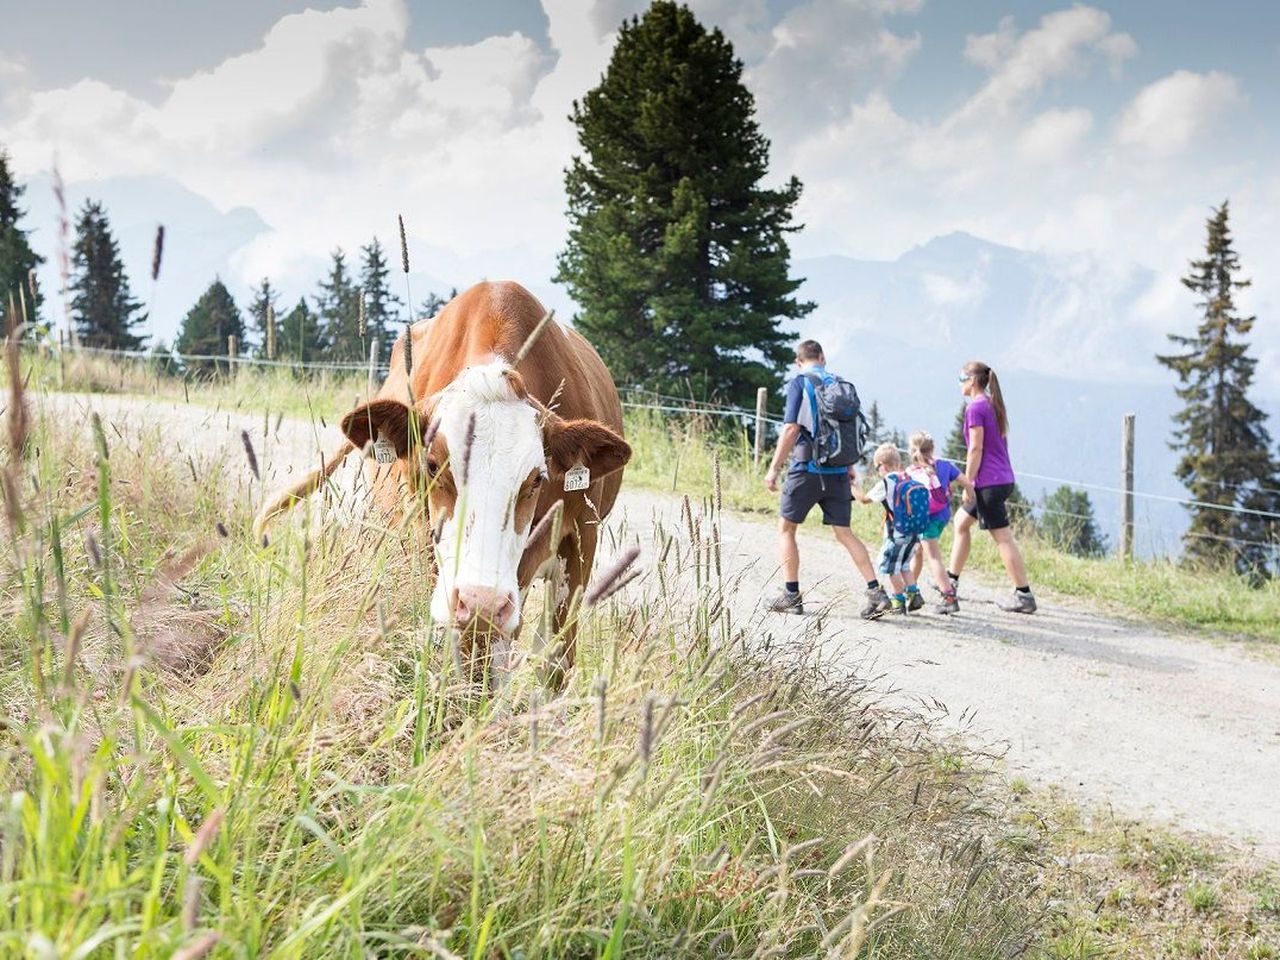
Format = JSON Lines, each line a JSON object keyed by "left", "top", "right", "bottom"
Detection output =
{"left": 30, "top": 346, "right": 1280, "bottom": 550}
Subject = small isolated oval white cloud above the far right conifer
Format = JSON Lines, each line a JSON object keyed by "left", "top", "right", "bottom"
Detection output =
{"left": 1116, "top": 70, "right": 1243, "bottom": 156}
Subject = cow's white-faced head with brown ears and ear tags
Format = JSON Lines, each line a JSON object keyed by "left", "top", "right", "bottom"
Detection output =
{"left": 342, "top": 361, "right": 631, "bottom": 675}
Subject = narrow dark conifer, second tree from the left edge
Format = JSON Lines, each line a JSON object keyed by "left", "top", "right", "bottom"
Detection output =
{"left": 70, "top": 200, "right": 146, "bottom": 349}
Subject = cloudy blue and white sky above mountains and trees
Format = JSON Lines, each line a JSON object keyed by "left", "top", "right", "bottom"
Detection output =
{"left": 0, "top": 0, "right": 1280, "bottom": 397}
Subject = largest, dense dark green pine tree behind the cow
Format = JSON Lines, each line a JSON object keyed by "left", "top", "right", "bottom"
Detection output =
{"left": 556, "top": 0, "right": 813, "bottom": 406}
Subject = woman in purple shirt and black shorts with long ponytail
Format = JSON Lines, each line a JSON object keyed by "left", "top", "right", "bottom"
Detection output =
{"left": 943, "top": 360, "right": 1036, "bottom": 613}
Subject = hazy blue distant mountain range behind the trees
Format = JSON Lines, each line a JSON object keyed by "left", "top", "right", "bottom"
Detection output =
{"left": 23, "top": 175, "right": 1280, "bottom": 553}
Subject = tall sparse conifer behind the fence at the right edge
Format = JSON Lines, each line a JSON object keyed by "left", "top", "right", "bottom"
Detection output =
{"left": 1157, "top": 201, "right": 1280, "bottom": 576}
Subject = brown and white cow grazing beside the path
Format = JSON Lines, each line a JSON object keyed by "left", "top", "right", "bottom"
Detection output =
{"left": 255, "top": 282, "right": 631, "bottom": 673}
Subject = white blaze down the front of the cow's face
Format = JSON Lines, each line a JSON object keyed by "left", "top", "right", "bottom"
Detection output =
{"left": 431, "top": 361, "right": 547, "bottom": 632}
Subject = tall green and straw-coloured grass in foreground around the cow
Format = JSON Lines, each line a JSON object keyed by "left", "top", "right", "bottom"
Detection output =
{"left": 0, "top": 358, "right": 1037, "bottom": 959}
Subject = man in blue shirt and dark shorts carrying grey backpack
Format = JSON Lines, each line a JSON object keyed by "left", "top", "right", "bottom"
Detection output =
{"left": 764, "top": 340, "right": 891, "bottom": 620}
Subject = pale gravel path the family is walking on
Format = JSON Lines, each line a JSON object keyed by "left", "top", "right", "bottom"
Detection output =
{"left": 44, "top": 396, "right": 1280, "bottom": 855}
